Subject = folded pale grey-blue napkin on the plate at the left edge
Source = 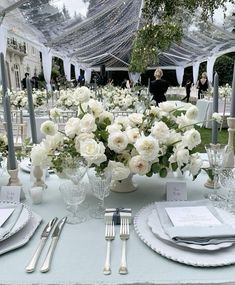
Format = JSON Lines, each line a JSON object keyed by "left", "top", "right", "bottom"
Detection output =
{"left": 0, "top": 204, "right": 23, "bottom": 241}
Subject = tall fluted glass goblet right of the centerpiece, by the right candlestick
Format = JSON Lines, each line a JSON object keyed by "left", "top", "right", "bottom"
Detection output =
{"left": 205, "top": 143, "right": 231, "bottom": 201}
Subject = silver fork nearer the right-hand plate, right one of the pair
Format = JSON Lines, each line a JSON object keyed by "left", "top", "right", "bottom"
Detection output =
{"left": 119, "top": 217, "right": 130, "bottom": 274}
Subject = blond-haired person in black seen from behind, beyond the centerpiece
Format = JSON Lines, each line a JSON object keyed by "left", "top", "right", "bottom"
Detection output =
{"left": 149, "top": 68, "right": 169, "bottom": 106}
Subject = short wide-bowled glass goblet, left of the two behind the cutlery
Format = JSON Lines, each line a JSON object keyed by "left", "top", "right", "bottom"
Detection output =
{"left": 59, "top": 181, "right": 86, "bottom": 224}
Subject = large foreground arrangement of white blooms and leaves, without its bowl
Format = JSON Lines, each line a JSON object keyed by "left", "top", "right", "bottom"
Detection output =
{"left": 31, "top": 90, "right": 206, "bottom": 193}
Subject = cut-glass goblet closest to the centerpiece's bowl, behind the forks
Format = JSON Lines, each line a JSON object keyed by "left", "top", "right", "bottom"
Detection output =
{"left": 87, "top": 168, "right": 112, "bottom": 219}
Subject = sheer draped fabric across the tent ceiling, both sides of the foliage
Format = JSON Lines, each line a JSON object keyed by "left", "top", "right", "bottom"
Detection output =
{"left": 0, "top": 0, "right": 235, "bottom": 73}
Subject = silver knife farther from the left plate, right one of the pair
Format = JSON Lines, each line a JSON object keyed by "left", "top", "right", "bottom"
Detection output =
{"left": 40, "top": 217, "right": 67, "bottom": 273}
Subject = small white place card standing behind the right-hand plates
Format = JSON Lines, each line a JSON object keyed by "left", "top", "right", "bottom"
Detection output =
{"left": 166, "top": 181, "right": 187, "bottom": 201}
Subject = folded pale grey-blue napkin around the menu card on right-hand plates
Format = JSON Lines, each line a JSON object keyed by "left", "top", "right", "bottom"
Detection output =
{"left": 156, "top": 200, "right": 235, "bottom": 245}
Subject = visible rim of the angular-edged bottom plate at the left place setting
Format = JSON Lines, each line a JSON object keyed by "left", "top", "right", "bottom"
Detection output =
{"left": 0, "top": 212, "right": 42, "bottom": 255}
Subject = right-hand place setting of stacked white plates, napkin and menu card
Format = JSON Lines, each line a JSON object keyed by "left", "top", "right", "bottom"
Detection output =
{"left": 134, "top": 199, "right": 235, "bottom": 267}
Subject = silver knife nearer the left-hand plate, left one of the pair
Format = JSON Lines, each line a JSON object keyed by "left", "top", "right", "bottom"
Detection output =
{"left": 25, "top": 217, "right": 58, "bottom": 273}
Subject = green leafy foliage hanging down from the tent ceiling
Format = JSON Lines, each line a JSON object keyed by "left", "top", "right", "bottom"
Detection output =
{"left": 129, "top": 0, "right": 234, "bottom": 72}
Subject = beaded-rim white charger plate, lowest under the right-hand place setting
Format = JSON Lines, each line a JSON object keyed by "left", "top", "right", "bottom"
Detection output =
{"left": 134, "top": 203, "right": 235, "bottom": 267}
